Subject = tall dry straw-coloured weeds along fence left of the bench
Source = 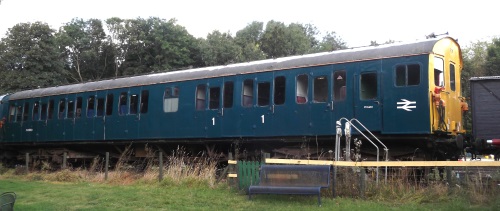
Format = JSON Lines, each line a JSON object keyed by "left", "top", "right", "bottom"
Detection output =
{"left": 0, "top": 146, "right": 218, "bottom": 187}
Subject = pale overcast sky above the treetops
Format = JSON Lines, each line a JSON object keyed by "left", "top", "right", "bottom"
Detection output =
{"left": 0, "top": 0, "right": 500, "bottom": 47}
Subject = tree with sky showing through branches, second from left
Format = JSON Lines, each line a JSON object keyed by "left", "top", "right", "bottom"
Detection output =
{"left": 58, "top": 18, "right": 114, "bottom": 82}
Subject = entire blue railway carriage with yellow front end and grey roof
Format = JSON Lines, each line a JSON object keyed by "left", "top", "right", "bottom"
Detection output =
{"left": 0, "top": 37, "right": 466, "bottom": 161}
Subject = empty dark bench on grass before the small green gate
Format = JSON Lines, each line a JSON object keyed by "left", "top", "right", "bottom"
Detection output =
{"left": 248, "top": 165, "right": 330, "bottom": 206}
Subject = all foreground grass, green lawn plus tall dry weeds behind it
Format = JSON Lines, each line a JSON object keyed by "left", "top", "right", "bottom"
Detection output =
{"left": 0, "top": 149, "right": 500, "bottom": 211}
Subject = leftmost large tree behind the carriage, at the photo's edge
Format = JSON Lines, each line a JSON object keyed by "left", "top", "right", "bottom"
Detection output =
{"left": 0, "top": 22, "right": 67, "bottom": 92}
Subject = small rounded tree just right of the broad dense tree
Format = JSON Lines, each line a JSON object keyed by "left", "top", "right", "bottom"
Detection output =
{"left": 200, "top": 30, "right": 241, "bottom": 66}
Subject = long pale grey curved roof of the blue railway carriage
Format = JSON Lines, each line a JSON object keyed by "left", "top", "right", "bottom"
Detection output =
{"left": 9, "top": 37, "right": 458, "bottom": 100}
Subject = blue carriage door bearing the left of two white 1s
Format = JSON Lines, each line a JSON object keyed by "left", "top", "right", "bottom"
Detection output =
{"left": 205, "top": 78, "right": 224, "bottom": 138}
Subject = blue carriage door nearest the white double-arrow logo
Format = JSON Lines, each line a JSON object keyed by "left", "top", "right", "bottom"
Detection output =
{"left": 354, "top": 71, "right": 382, "bottom": 131}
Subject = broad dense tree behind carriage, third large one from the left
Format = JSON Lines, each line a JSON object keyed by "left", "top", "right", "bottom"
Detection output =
{"left": 120, "top": 17, "right": 203, "bottom": 75}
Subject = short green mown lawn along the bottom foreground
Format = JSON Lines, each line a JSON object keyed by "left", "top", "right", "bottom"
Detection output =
{"left": 0, "top": 179, "right": 500, "bottom": 210}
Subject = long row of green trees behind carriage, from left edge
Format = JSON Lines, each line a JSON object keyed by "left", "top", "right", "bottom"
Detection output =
{"left": 0, "top": 17, "right": 352, "bottom": 92}
